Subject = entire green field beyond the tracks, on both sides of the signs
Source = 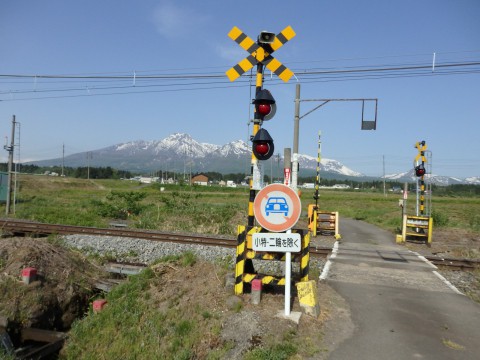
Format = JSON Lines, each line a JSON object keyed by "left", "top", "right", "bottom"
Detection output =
{"left": 0, "top": 175, "right": 480, "bottom": 235}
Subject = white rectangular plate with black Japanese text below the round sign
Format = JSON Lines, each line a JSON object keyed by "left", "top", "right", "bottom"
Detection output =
{"left": 252, "top": 233, "right": 302, "bottom": 252}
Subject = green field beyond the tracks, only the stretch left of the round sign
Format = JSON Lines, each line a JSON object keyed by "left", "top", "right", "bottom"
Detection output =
{"left": 7, "top": 175, "right": 248, "bottom": 235}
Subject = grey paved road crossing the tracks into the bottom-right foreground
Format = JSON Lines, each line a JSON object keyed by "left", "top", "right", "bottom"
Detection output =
{"left": 321, "top": 219, "right": 480, "bottom": 360}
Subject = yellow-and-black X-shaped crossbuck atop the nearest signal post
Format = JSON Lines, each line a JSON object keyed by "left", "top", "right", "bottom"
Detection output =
{"left": 226, "top": 26, "right": 296, "bottom": 82}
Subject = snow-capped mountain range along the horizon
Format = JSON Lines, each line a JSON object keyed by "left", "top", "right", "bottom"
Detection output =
{"left": 28, "top": 133, "right": 480, "bottom": 185}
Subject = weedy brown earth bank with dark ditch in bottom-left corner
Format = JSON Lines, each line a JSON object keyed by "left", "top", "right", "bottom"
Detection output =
{"left": 0, "top": 237, "right": 146, "bottom": 359}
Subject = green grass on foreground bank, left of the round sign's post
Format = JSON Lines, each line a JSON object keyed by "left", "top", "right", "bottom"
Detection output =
{"left": 60, "top": 253, "right": 228, "bottom": 360}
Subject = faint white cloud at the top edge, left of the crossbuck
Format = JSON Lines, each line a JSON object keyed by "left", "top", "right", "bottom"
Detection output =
{"left": 153, "top": 1, "right": 209, "bottom": 39}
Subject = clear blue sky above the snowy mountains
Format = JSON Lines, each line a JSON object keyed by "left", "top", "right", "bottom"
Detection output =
{"left": 0, "top": 0, "right": 480, "bottom": 177}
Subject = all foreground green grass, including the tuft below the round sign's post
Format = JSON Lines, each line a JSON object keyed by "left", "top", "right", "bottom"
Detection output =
{"left": 59, "top": 252, "right": 320, "bottom": 360}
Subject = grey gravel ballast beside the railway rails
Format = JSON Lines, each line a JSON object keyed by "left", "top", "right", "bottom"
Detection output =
{"left": 63, "top": 235, "right": 480, "bottom": 298}
